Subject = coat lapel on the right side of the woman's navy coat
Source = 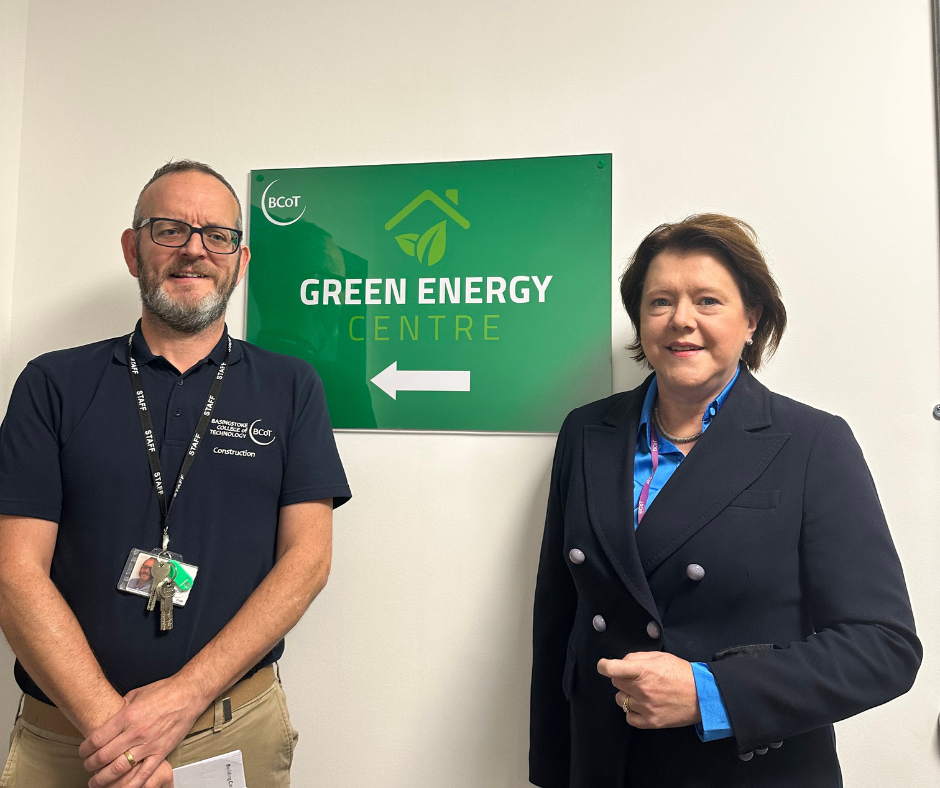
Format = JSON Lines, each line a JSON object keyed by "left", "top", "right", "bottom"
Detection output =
{"left": 631, "top": 369, "right": 790, "bottom": 576}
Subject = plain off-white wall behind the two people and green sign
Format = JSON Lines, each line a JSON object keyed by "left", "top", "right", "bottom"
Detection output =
{"left": 0, "top": 0, "right": 940, "bottom": 788}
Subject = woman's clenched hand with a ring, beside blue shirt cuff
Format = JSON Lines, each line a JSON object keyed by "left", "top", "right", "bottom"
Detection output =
{"left": 597, "top": 651, "right": 702, "bottom": 728}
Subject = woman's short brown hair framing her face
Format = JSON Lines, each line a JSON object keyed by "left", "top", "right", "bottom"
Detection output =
{"left": 620, "top": 213, "right": 787, "bottom": 370}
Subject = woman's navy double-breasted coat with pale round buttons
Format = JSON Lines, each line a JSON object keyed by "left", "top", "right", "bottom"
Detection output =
{"left": 529, "top": 370, "right": 922, "bottom": 788}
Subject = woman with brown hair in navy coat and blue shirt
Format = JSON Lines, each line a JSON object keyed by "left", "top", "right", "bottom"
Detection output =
{"left": 529, "top": 214, "right": 922, "bottom": 788}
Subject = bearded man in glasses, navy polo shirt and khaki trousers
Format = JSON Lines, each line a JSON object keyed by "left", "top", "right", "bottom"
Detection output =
{"left": 0, "top": 161, "right": 350, "bottom": 788}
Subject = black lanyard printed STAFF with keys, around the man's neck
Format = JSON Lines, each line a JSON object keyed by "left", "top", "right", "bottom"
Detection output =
{"left": 127, "top": 331, "right": 232, "bottom": 630}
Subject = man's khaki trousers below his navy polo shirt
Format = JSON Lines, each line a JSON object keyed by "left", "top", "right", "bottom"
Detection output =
{"left": 0, "top": 681, "right": 298, "bottom": 788}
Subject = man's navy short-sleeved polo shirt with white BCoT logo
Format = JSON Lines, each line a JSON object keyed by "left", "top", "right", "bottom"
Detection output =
{"left": 0, "top": 324, "right": 350, "bottom": 702}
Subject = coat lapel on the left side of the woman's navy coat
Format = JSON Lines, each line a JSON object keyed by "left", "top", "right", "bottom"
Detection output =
{"left": 584, "top": 376, "right": 659, "bottom": 619}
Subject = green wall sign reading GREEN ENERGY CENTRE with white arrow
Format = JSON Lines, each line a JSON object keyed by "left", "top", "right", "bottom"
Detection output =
{"left": 247, "top": 154, "right": 611, "bottom": 432}
